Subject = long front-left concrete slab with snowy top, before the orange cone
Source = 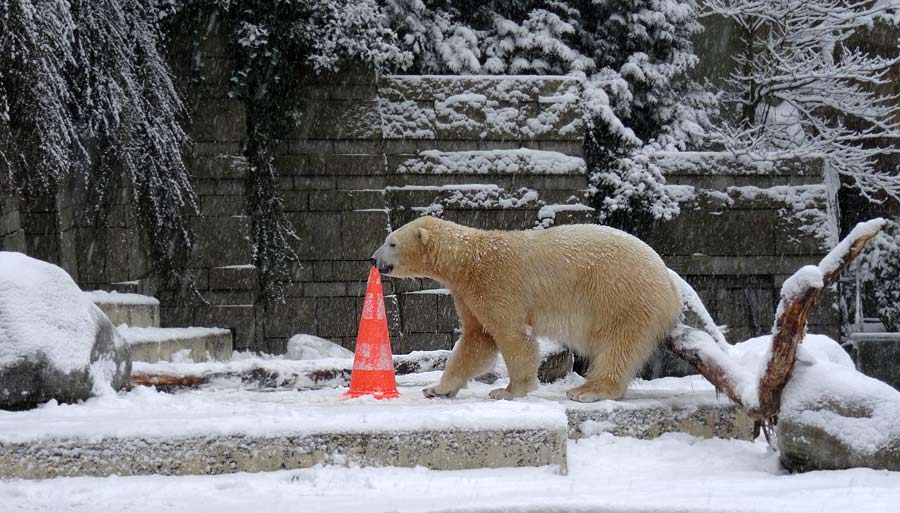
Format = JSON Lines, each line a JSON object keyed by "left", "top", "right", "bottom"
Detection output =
{"left": 0, "top": 387, "right": 566, "bottom": 479}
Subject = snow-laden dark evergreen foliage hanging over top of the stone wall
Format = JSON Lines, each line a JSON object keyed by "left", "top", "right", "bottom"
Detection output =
{"left": 386, "top": 0, "right": 713, "bottom": 227}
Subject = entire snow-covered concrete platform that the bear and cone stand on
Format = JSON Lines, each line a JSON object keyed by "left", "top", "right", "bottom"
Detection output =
{"left": 0, "top": 372, "right": 752, "bottom": 479}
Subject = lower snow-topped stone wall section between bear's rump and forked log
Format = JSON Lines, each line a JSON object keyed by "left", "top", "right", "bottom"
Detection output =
{"left": 636, "top": 153, "right": 840, "bottom": 341}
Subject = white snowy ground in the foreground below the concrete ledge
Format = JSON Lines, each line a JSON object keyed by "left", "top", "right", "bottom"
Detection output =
{"left": 0, "top": 434, "right": 900, "bottom": 513}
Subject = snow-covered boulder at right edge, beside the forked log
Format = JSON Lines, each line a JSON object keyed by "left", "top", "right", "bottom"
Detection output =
{"left": 778, "top": 337, "right": 900, "bottom": 472}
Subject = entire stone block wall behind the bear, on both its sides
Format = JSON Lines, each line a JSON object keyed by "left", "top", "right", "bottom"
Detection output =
{"left": 0, "top": 35, "right": 839, "bottom": 353}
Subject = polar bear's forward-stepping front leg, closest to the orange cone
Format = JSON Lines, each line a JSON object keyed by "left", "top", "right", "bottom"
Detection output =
{"left": 422, "top": 302, "right": 497, "bottom": 398}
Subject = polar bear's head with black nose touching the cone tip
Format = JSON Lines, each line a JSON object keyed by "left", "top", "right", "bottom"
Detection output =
{"left": 372, "top": 216, "right": 443, "bottom": 278}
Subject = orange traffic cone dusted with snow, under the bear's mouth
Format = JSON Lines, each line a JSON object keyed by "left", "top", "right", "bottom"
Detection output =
{"left": 345, "top": 267, "right": 400, "bottom": 399}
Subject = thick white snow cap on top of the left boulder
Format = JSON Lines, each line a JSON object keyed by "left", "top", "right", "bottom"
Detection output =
{"left": 0, "top": 251, "right": 103, "bottom": 372}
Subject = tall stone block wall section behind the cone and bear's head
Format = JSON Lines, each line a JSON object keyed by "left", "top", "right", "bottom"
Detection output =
{"left": 166, "top": 72, "right": 590, "bottom": 352}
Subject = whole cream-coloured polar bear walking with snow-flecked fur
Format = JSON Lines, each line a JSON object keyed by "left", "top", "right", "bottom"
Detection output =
{"left": 372, "top": 217, "right": 682, "bottom": 402}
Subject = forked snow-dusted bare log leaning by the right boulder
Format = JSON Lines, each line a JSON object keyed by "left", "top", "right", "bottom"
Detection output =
{"left": 667, "top": 218, "right": 885, "bottom": 439}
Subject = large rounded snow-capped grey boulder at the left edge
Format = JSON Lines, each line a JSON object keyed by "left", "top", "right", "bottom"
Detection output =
{"left": 0, "top": 251, "right": 131, "bottom": 409}
